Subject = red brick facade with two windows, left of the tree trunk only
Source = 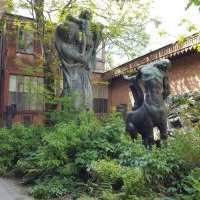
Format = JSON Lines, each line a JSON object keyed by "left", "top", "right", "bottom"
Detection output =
{"left": 0, "top": 14, "right": 44, "bottom": 125}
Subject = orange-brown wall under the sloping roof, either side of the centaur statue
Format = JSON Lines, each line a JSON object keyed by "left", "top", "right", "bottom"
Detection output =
{"left": 109, "top": 53, "right": 200, "bottom": 111}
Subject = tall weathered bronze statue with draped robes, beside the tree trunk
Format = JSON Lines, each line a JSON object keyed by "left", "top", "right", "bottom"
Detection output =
{"left": 55, "top": 10, "right": 101, "bottom": 110}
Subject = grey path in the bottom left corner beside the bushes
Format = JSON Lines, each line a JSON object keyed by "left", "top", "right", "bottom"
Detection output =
{"left": 0, "top": 178, "right": 33, "bottom": 200}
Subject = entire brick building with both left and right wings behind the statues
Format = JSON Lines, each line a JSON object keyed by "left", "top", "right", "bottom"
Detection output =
{"left": 0, "top": 14, "right": 200, "bottom": 125}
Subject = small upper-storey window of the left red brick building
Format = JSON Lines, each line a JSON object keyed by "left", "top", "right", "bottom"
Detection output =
{"left": 17, "top": 26, "right": 33, "bottom": 53}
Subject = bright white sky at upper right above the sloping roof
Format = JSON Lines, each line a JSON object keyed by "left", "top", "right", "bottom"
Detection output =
{"left": 145, "top": 0, "right": 200, "bottom": 51}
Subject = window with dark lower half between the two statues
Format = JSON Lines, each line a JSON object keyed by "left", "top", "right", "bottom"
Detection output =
{"left": 93, "top": 84, "right": 108, "bottom": 113}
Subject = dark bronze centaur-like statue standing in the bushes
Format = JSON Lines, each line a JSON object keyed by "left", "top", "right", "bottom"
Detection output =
{"left": 124, "top": 59, "right": 171, "bottom": 147}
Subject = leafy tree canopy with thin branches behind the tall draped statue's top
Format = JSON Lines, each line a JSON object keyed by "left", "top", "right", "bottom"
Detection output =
{"left": 13, "top": 0, "right": 153, "bottom": 67}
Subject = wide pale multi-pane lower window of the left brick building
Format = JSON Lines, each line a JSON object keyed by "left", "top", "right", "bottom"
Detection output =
{"left": 9, "top": 75, "right": 44, "bottom": 111}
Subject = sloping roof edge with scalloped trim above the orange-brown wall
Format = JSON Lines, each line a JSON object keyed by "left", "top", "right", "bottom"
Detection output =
{"left": 103, "top": 33, "right": 200, "bottom": 80}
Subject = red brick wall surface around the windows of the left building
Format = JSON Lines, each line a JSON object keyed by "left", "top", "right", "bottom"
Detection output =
{"left": 0, "top": 18, "right": 44, "bottom": 124}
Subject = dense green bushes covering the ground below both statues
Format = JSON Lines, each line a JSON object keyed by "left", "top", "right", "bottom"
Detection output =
{"left": 0, "top": 102, "right": 200, "bottom": 200}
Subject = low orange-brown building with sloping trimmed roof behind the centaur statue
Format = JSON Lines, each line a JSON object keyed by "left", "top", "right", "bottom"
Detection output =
{"left": 102, "top": 33, "right": 200, "bottom": 111}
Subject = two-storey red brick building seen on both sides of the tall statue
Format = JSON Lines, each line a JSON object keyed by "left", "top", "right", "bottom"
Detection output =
{"left": 0, "top": 14, "right": 108, "bottom": 126}
